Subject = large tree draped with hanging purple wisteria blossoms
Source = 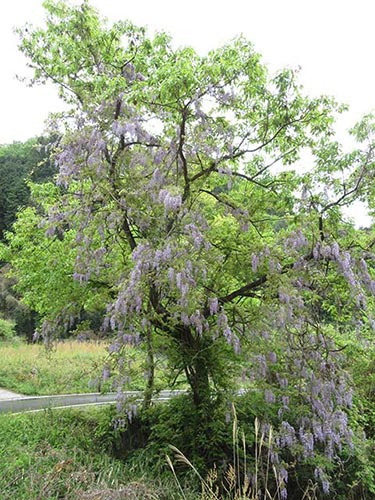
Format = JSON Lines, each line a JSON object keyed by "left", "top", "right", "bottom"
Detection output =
{"left": 5, "top": 0, "right": 375, "bottom": 490}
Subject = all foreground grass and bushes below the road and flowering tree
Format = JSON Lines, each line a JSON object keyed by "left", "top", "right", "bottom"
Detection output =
{"left": 0, "top": 395, "right": 374, "bottom": 500}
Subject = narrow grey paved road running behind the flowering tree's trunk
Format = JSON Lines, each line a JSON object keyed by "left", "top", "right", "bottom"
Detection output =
{"left": 0, "top": 389, "right": 184, "bottom": 413}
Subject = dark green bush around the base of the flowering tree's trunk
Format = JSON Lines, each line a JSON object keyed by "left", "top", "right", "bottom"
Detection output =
{"left": 105, "top": 391, "right": 375, "bottom": 500}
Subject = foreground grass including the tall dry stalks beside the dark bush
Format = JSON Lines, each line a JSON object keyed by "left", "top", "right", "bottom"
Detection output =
{"left": 0, "top": 400, "right": 320, "bottom": 500}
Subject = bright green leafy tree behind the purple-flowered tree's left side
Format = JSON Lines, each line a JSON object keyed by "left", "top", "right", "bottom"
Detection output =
{"left": 0, "top": 182, "right": 108, "bottom": 336}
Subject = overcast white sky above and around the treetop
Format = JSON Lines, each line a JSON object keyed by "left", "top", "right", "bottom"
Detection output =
{"left": 0, "top": 0, "right": 375, "bottom": 144}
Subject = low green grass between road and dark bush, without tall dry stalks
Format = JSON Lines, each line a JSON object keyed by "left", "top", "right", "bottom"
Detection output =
{"left": 0, "top": 407, "right": 197, "bottom": 500}
